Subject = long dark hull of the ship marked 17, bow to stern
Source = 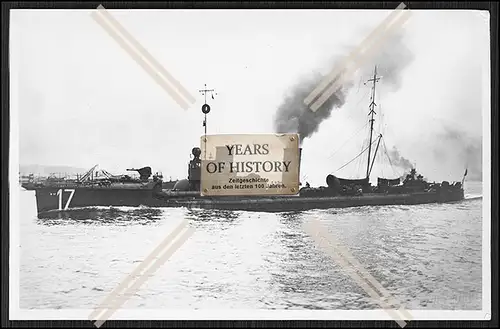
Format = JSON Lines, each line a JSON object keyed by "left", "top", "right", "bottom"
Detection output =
{"left": 26, "top": 183, "right": 464, "bottom": 214}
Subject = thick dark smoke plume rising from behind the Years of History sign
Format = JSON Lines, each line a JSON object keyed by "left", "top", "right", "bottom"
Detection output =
{"left": 274, "top": 31, "right": 413, "bottom": 141}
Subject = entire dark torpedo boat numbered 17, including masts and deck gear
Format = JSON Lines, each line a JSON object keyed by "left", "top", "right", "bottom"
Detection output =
{"left": 23, "top": 68, "right": 467, "bottom": 214}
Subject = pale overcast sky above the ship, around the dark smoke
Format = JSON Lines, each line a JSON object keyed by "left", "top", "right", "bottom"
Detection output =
{"left": 10, "top": 10, "right": 489, "bottom": 185}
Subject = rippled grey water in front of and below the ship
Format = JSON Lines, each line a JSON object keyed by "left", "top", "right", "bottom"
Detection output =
{"left": 20, "top": 183, "right": 482, "bottom": 310}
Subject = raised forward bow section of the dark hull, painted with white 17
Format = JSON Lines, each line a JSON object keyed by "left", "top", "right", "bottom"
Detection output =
{"left": 34, "top": 187, "right": 161, "bottom": 214}
